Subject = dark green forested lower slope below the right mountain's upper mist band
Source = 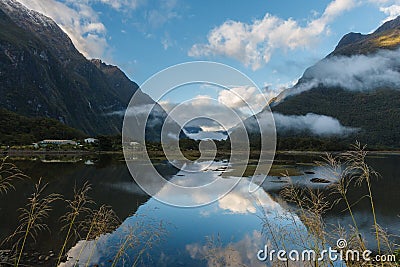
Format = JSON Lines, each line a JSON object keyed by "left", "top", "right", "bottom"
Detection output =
{"left": 272, "top": 87, "right": 400, "bottom": 151}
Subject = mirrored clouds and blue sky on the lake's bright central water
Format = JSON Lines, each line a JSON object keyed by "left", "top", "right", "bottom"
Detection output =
{"left": 62, "top": 163, "right": 306, "bottom": 266}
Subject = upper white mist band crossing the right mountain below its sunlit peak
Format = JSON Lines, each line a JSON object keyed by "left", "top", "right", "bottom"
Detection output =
{"left": 278, "top": 49, "right": 400, "bottom": 100}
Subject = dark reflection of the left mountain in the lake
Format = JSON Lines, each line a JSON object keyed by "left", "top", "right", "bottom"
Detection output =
{"left": 0, "top": 156, "right": 176, "bottom": 255}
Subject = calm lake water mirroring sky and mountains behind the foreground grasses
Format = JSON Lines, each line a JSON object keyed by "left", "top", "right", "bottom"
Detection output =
{"left": 0, "top": 155, "right": 400, "bottom": 266}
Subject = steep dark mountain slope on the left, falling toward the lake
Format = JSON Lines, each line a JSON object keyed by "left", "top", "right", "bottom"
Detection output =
{"left": 0, "top": 0, "right": 163, "bottom": 138}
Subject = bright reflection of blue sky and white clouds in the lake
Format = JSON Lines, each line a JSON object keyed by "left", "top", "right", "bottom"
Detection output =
{"left": 61, "top": 161, "right": 305, "bottom": 266}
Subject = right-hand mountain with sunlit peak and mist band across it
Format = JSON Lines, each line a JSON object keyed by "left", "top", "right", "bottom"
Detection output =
{"left": 270, "top": 17, "right": 400, "bottom": 148}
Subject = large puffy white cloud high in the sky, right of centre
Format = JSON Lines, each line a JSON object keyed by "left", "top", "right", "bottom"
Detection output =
{"left": 189, "top": 0, "right": 355, "bottom": 70}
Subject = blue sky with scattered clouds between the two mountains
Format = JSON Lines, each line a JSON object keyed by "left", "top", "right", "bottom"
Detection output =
{"left": 19, "top": 0, "right": 400, "bottom": 99}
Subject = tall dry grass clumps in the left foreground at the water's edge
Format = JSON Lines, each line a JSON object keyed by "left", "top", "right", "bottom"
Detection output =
{"left": 0, "top": 158, "right": 166, "bottom": 266}
